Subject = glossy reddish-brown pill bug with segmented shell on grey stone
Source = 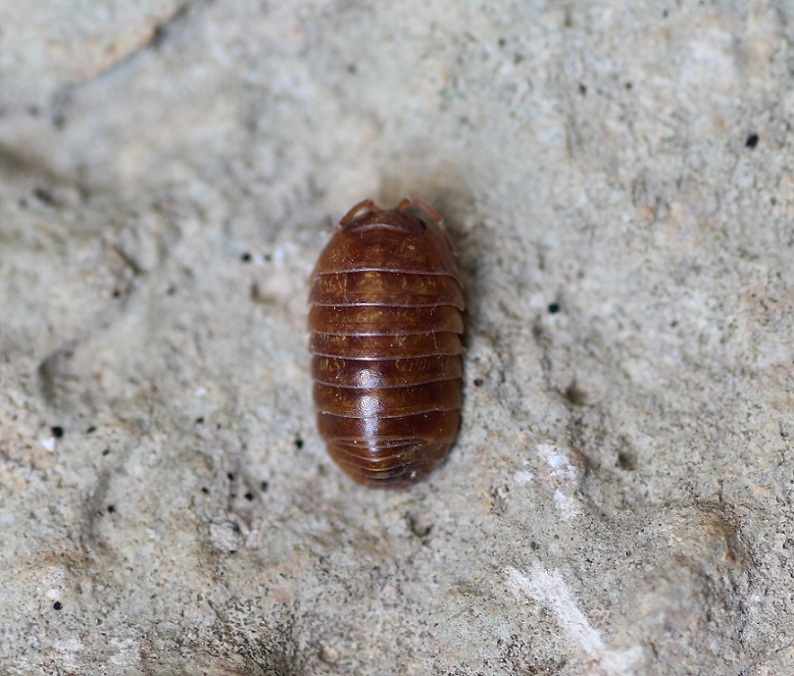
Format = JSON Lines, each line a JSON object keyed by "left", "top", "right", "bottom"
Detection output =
{"left": 309, "top": 197, "right": 464, "bottom": 488}
